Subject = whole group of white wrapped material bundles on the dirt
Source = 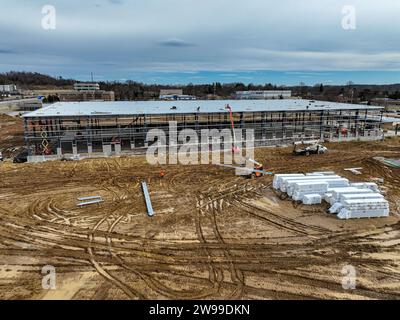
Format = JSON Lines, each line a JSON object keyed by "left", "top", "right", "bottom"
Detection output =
{"left": 273, "top": 171, "right": 390, "bottom": 219}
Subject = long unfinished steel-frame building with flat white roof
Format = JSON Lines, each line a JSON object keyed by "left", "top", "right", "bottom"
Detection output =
{"left": 23, "top": 100, "right": 382, "bottom": 159}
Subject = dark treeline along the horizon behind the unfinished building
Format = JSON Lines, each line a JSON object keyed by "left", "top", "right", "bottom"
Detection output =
{"left": 0, "top": 71, "right": 400, "bottom": 102}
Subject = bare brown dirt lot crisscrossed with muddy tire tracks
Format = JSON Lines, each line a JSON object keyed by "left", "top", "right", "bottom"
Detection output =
{"left": 0, "top": 133, "right": 400, "bottom": 299}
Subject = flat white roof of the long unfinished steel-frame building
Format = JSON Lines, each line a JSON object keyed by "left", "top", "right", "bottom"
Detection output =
{"left": 23, "top": 99, "right": 382, "bottom": 118}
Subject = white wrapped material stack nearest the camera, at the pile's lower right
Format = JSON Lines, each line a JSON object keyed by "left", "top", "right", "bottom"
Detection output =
{"left": 338, "top": 199, "right": 390, "bottom": 219}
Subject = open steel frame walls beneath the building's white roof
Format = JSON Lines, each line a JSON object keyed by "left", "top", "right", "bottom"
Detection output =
{"left": 24, "top": 108, "right": 382, "bottom": 156}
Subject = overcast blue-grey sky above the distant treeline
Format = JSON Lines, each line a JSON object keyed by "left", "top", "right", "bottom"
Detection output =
{"left": 0, "top": 0, "right": 400, "bottom": 84}
